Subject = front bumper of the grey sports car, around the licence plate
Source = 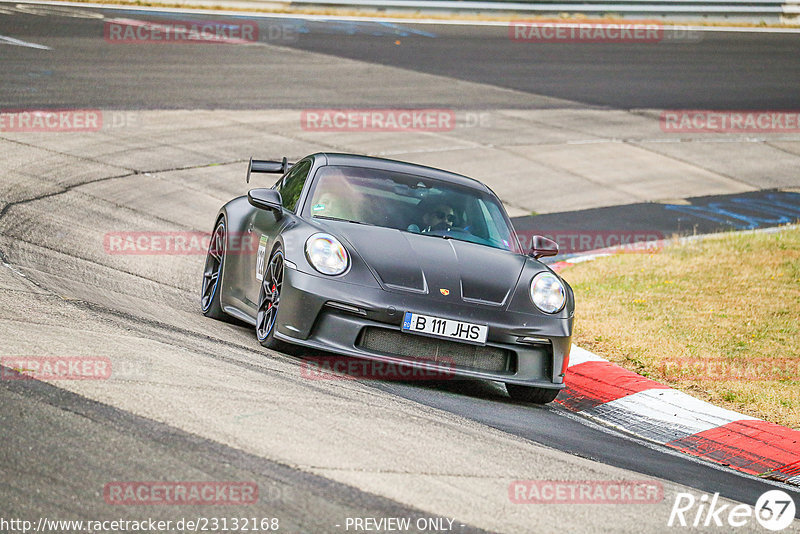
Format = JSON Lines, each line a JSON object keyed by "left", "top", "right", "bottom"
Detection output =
{"left": 275, "top": 268, "right": 572, "bottom": 389}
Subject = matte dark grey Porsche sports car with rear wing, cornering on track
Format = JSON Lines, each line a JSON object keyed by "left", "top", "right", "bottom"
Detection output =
{"left": 202, "top": 153, "right": 575, "bottom": 403}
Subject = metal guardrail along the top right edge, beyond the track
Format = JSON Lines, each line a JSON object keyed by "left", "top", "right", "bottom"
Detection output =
{"left": 291, "top": 0, "right": 800, "bottom": 23}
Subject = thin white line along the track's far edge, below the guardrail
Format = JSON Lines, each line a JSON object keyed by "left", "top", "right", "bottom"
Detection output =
{"left": 0, "top": 0, "right": 800, "bottom": 33}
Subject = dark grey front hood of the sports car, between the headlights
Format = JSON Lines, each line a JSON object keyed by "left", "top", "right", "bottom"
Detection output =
{"left": 331, "top": 223, "right": 526, "bottom": 306}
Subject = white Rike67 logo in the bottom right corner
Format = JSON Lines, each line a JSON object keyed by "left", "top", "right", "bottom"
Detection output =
{"left": 667, "top": 490, "right": 797, "bottom": 532}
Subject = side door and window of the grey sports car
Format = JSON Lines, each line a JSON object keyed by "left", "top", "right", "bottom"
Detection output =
{"left": 246, "top": 159, "right": 312, "bottom": 315}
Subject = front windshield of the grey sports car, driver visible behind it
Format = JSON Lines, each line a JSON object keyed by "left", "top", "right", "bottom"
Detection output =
{"left": 309, "top": 166, "right": 520, "bottom": 252}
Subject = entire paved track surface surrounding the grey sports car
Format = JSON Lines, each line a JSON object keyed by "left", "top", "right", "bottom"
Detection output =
{"left": 0, "top": 3, "right": 800, "bottom": 532}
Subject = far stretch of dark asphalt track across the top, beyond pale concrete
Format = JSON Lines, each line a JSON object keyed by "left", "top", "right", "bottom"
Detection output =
{"left": 0, "top": 4, "right": 800, "bottom": 110}
